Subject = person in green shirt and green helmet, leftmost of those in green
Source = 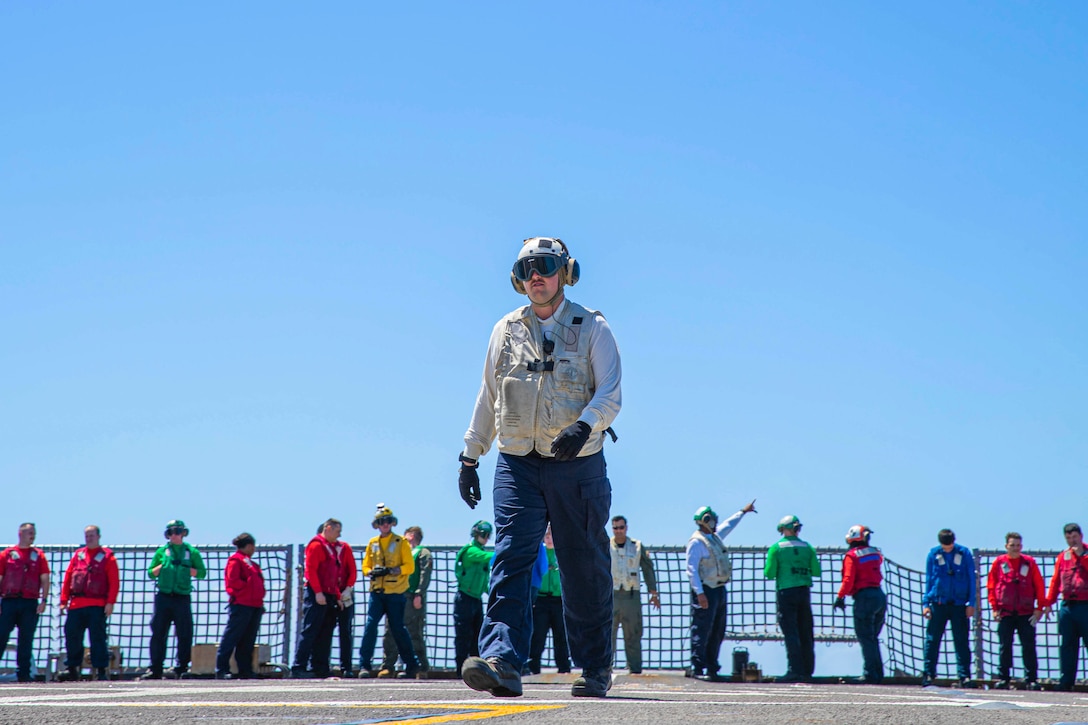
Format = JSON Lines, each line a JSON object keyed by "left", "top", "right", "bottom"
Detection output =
{"left": 143, "top": 518, "right": 208, "bottom": 679}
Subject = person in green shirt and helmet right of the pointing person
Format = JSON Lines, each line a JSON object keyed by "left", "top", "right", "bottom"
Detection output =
{"left": 763, "top": 516, "right": 820, "bottom": 683}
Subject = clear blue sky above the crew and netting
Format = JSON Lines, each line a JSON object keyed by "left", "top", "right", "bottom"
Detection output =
{"left": 0, "top": 2, "right": 1088, "bottom": 566}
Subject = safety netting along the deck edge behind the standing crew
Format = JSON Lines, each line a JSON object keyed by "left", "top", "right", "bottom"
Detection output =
{"left": 0, "top": 545, "right": 1088, "bottom": 678}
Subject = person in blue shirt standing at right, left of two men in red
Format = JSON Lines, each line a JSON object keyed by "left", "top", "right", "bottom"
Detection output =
{"left": 922, "top": 529, "right": 976, "bottom": 687}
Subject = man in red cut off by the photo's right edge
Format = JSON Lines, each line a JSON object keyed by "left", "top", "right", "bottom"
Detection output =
{"left": 1044, "top": 524, "right": 1088, "bottom": 692}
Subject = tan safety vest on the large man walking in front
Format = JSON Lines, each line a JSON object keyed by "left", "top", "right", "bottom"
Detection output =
{"left": 495, "top": 303, "right": 604, "bottom": 457}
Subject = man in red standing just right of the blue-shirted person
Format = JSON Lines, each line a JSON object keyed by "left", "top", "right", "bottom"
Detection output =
{"left": 986, "top": 531, "right": 1047, "bottom": 690}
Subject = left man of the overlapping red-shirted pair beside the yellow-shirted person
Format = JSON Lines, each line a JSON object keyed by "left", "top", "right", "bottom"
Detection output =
{"left": 290, "top": 518, "right": 344, "bottom": 679}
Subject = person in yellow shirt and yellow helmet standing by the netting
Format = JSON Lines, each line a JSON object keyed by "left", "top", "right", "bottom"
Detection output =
{"left": 359, "top": 503, "right": 420, "bottom": 677}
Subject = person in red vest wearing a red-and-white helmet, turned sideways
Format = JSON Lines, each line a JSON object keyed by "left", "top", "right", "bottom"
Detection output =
{"left": 832, "top": 525, "right": 888, "bottom": 685}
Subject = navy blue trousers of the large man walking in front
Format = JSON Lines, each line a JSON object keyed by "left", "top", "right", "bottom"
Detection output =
{"left": 480, "top": 453, "right": 613, "bottom": 671}
